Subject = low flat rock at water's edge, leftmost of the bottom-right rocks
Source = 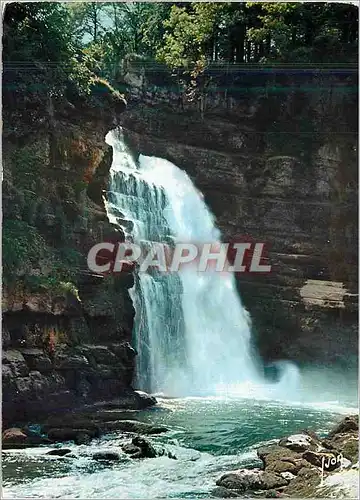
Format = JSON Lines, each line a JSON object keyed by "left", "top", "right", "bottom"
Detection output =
{"left": 216, "top": 469, "right": 288, "bottom": 491}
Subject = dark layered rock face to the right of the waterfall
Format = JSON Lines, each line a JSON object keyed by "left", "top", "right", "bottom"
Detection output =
{"left": 121, "top": 64, "right": 357, "bottom": 364}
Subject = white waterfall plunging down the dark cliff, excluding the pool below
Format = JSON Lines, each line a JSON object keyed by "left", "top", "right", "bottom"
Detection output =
{"left": 106, "top": 130, "right": 297, "bottom": 397}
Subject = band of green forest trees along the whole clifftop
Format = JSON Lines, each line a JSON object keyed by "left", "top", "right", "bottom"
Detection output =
{"left": 4, "top": 2, "right": 358, "bottom": 87}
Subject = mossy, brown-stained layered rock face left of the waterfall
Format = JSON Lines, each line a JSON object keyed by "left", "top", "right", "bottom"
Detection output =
{"left": 2, "top": 91, "right": 143, "bottom": 425}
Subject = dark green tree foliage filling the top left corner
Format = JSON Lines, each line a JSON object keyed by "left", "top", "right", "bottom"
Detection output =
{"left": 3, "top": 2, "right": 100, "bottom": 127}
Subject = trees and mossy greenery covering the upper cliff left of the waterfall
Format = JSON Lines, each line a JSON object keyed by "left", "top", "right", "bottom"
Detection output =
{"left": 3, "top": 3, "right": 124, "bottom": 290}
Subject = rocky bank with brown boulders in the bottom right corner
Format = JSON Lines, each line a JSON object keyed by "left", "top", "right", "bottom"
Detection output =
{"left": 215, "top": 415, "right": 359, "bottom": 498}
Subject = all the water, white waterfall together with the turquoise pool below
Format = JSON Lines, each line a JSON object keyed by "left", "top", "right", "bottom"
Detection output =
{"left": 2, "top": 130, "right": 357, "bottom": 500}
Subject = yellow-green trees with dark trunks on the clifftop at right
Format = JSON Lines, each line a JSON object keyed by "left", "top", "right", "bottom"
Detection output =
{"left": 157, "top": 2, "right": 358, "bottom": 71}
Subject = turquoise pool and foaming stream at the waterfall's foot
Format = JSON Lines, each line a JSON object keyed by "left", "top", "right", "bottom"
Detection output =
{"left": 3, "top": 398, "right": 356, "bottom": 499}
